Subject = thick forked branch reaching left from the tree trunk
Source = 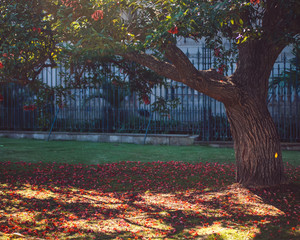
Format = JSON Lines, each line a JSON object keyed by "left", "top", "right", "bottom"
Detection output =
{"left": 121, "top": 45, "right": 236, "bottom": 104}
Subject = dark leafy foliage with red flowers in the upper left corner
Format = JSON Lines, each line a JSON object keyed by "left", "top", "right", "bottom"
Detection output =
{"left": 0, "top": 0, "right": 59, "bottom": 84}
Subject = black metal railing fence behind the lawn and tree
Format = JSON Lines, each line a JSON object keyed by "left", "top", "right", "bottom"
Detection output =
{"left": 0, "top": 47, "right": 300, "bottom": 142}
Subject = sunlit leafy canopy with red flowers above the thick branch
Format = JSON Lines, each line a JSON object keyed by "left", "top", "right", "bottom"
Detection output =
{"left": 51, "top": 0, "right": 299, "bottom": 64}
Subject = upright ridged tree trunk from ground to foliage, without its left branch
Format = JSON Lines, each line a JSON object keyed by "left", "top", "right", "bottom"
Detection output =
{"left": 223, "top": 40, "right": 286, "bottom": 186}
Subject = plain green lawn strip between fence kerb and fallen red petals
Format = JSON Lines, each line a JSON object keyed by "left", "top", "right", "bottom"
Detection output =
{"left": 0, "top": 138, "right": 300, "bottom": 166}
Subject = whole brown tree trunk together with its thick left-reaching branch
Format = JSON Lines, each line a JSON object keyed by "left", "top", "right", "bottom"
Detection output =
{"left": 126, "top": 40, "right": 285, "bottom": 187}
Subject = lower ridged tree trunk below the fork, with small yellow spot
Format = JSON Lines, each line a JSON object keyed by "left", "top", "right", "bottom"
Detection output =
{"left": 226, "top": 98, "right": 285, "bottom": 186}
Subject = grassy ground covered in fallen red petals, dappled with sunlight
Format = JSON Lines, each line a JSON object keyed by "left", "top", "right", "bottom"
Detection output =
{"left": 0, "top": 162, "right": 300, "bottom": 239}
